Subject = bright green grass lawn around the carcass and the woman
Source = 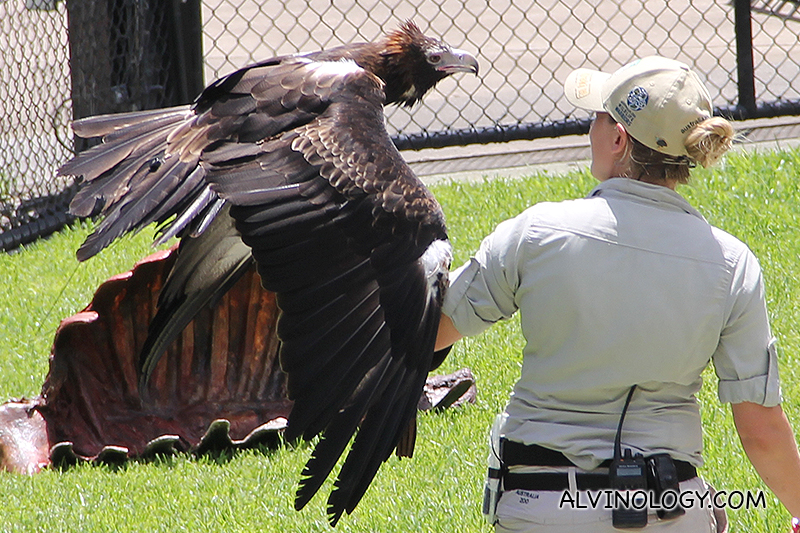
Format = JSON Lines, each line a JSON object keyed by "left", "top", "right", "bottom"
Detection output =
{"left": 0, "top": 151, "right": 800, "bottom": 532}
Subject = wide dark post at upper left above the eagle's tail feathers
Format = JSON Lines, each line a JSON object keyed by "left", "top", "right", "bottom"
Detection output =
{"left": 67, "top": 0, "right": 204, "bottom": 151}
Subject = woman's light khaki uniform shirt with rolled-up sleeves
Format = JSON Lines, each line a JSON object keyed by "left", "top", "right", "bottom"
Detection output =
{"left": 444, "top": 178, "right": 780, "bottom": 469}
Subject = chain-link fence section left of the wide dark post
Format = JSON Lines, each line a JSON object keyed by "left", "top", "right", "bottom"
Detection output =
{"left": 0, "top": 1, "right": 72, "bottom": 249}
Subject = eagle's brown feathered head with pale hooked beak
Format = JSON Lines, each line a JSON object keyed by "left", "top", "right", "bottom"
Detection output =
{"left": 375, "top": 21, "right": 478, "bottom": 107}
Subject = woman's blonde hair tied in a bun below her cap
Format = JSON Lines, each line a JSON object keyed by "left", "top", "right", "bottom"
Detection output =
{"left": 629, "top": 117, "right": 736, "bottom": 183}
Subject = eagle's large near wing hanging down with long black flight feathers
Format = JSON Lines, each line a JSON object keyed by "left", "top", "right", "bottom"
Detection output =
{"left": 207, "top": 63, "right": 449, "bottom": 523}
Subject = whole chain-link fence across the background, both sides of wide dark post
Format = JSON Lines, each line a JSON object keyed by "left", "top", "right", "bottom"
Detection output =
{"left": 0, "top": 0, "right": 800, "bottom": 248}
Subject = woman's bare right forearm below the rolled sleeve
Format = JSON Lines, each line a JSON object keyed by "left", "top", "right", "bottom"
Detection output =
{"left": 731, "top": 402, "right": 800, "bottom": 516}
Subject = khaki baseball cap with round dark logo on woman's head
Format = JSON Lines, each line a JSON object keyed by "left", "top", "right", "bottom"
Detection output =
{"left": 564, "top": 56, "right": 713, "bottom": 156}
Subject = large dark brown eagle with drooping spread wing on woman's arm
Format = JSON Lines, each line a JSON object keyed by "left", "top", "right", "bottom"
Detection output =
{"left": 59, "top": 22, "right": 478, "bottom": 526}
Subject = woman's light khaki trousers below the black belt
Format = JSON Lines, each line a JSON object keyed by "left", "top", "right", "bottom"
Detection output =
{"left": 495, "top": 477, "right": 728, "bottom": 533}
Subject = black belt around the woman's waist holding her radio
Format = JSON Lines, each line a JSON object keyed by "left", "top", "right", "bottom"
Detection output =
{"left": 500, "top": 439, "right": 697, "bottom": 490}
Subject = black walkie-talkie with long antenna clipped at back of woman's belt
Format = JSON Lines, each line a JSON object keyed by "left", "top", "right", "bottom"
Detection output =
{"left": 608, "top": 385, "right": 647, "bottom": 529}
